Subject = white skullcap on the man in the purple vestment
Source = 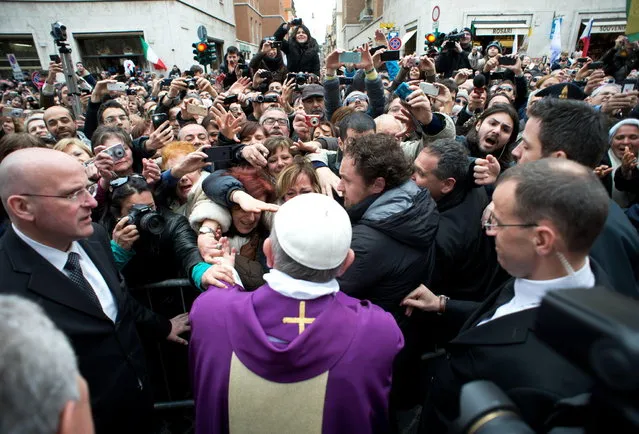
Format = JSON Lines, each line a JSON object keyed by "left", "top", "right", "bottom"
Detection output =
{"left": 273, "top": 193, "right": 352, "bottom": 270}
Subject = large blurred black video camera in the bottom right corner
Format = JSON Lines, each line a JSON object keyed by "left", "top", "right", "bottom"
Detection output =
{"left": 452, "top": 287, "right": 639, "bottom": 434}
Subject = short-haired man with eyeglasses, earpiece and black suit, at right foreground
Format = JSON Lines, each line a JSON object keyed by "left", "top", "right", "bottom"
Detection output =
{"left": 402, "top": 159, "right": 612, "bottom": 433}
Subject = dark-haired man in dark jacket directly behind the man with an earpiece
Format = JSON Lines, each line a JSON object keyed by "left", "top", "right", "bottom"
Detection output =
{"left": 512, "top": 98, "right": 639, "bottom": 298}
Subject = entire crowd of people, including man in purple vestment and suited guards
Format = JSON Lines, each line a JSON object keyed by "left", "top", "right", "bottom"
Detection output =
{"left": 0, "top": 20, "right": 639, "bottom": 433}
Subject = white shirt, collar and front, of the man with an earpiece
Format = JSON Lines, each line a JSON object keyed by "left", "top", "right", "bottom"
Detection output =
{"left": 477, "top": 258, "right": 595, "bottom": 326}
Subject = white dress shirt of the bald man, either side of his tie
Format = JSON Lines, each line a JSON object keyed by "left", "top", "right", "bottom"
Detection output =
{"left": 12, "top": 225, "right": 118, "bottom": 322}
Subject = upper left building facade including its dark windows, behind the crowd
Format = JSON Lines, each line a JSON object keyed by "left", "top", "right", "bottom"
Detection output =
{"left": 0, "top": 0, "right": 236, "bottom": 77}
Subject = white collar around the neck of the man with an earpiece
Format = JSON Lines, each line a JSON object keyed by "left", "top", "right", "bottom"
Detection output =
{"left": 514, "top": 257, "right": 595, "bottom": 306}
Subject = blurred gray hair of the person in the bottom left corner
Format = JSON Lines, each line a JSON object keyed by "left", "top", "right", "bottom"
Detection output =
{"left": 0, "top": 295, "right": 80, "bottom": 434}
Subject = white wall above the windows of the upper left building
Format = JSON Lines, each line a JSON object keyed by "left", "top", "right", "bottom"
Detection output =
{"left": 0, "top": 0, "right": 237, "bottom": 69}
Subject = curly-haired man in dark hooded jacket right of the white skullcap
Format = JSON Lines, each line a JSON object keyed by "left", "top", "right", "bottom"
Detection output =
{"left": 337, "top": 134, "right": 439, "bottom": 419}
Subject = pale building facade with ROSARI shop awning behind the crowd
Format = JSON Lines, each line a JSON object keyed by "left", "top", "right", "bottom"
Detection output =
{"left": 332, "top": 0, "right": 626, "bottom": 57}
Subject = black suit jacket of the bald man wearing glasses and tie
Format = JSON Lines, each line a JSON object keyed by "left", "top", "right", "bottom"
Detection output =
{"left": 0, "top": 225, "right": 171, "bottom": 433}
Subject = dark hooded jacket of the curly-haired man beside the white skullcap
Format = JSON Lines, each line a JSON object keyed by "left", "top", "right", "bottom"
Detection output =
{"left": 337, "top": 180, "right": 439, "bottom": 327}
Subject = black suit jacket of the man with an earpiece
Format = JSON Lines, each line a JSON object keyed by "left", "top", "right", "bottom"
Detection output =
{"left": 420, "top": 259, "right": 609, "bottom": 433}
